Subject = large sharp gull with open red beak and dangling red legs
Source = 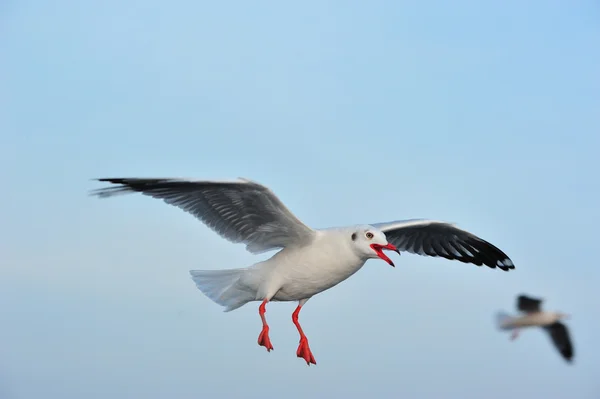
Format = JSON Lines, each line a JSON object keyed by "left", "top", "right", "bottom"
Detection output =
{"left": 92, "top": 178, "right": 514, "bottom": 366}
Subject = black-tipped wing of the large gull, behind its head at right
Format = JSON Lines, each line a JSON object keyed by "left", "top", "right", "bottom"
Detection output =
{"left": 371, "top": 219, "right": 515, "bottom": 271}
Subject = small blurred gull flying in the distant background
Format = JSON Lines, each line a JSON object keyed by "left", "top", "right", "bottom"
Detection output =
{"left": 496, "top": 295, "right": 574, "bottom": 362}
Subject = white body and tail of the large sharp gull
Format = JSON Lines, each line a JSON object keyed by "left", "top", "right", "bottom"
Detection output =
{"left": 190, "top": 229, "right": 369, "bottom": 311}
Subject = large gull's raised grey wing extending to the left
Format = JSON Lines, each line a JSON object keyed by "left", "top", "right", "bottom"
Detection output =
{"left": 92, "top": 178, "right": 314, "bottom": 253}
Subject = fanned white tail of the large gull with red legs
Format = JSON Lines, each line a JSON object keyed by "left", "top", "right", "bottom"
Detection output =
{"left": 190, "top": 268, "right": 256, "bottom": 312}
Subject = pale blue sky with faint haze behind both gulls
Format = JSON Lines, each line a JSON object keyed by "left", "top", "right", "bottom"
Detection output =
{"left": 0, "top": 0, "right": 600, "bottom": 399}
